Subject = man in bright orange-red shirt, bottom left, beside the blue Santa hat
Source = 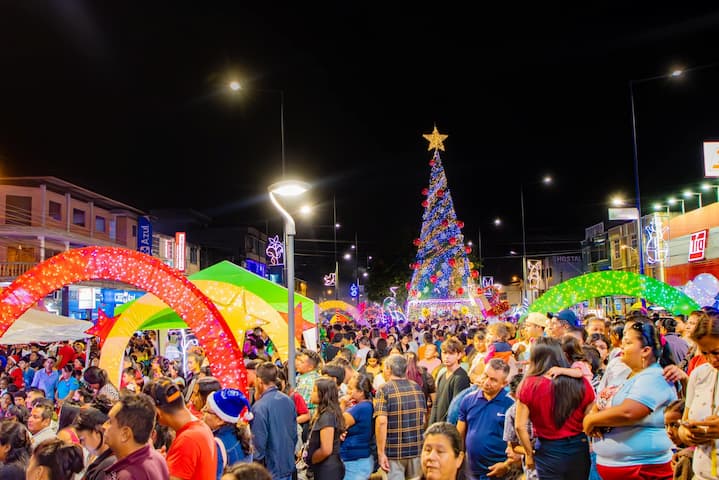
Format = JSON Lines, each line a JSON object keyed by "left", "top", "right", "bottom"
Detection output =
{"left": 144, "top": 377, "right": 217, "bottom": 480}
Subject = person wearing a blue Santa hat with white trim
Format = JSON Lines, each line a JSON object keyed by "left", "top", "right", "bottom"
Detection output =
{"left": 202, "top": 388, "right": 252, "bottom": 480}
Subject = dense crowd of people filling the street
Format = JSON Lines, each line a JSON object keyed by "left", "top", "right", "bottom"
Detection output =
{"left": 0, "top": 307, "right": 719, "bottom": 480}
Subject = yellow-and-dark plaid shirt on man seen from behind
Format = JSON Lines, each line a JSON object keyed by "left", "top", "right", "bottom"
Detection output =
{"left": 374, "top": 378, "right": 427, "bottom": 460}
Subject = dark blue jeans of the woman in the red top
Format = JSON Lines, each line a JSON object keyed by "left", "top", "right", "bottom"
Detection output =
{"left": 534, "top": 433, "right": 591, "bottom": 480}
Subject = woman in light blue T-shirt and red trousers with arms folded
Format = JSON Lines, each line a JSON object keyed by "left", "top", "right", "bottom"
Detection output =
{"left": 584, "top": 315, "right": 677, "bottom": 480}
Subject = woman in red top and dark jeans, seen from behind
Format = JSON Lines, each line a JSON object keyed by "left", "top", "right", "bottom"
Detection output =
{"left": 515, "top": 338, "right": 594, "bottom": 480}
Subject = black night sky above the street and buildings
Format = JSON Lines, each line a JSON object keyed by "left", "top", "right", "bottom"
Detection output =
{"left": 0, "top": 1, "right": 719, "bottom": 281}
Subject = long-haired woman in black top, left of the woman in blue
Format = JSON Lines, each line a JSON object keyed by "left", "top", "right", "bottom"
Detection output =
{"left": 305, "top": 377, "right": 345, "bottom": 480}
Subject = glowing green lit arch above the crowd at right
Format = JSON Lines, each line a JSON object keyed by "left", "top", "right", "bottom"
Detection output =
{"left": 529, "top": 270, "right": 699, "bottom": 315}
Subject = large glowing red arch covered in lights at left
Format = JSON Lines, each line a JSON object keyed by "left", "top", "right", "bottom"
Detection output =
{"left": 0, "top": 247, "right": 247, "bottom": 391}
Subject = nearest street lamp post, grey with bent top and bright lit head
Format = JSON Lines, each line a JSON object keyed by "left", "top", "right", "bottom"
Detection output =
{"left": 267, "top": 180, "right": 310, "bottom": 388}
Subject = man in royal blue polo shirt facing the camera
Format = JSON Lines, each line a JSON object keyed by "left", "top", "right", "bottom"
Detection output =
{"left": 457, "top": 358, "right": 514, "bottom": 480}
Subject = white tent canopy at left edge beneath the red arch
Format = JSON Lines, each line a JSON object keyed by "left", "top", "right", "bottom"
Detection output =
{"left": 0, "top": 308, "right": 92, "bottom": 345}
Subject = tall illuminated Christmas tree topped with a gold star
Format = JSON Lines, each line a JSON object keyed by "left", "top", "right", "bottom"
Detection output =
{"left": 407, "top": 126, "right": 482, "bottom": 320}
